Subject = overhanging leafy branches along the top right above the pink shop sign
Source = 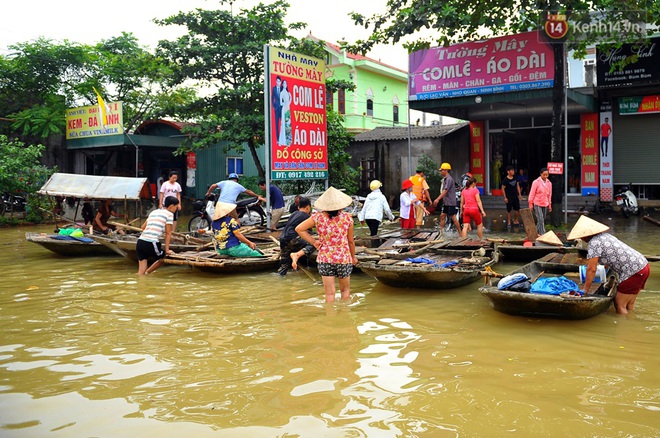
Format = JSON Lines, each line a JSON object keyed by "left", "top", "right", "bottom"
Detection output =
{"left": 350, "top": 0, "right": 660, "bottom": 54}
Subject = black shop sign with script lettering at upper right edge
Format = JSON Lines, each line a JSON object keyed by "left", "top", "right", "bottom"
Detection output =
{"left": 596, "top": 38, "right": 660, "bottom": 87}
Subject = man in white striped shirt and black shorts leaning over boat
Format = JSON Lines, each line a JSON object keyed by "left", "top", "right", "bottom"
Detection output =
{"left": 135, "top": 196, "right": 179, "bottom": 275}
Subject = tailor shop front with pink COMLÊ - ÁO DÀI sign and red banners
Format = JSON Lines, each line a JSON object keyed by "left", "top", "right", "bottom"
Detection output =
{"left": 409, "top": 32, "right": 598, "bottom": 196}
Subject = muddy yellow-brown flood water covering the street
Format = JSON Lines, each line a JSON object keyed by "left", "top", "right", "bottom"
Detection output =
{"left": 0, "top": 218, "right": 660, "bottom": 438}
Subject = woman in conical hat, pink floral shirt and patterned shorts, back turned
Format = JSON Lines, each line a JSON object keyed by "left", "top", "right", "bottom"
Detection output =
{"left": 296, "top": 187, "right": 357, "bottom": 303}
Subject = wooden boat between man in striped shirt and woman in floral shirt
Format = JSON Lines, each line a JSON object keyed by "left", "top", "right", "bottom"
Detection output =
{"left": 164, "top": 246, "right": 280, "bottom": 274}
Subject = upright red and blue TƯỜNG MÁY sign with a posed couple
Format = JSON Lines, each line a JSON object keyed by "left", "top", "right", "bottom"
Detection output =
{"left": 266, "top": 47, "right": 328, "bottom": 180}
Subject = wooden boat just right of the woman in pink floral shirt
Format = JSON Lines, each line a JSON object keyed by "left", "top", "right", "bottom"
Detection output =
{"left": 358, "top": 249, "right": 498, "bottom": 289}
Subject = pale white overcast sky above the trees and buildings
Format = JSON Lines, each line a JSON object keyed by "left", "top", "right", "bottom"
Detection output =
{"left": 0, "top": 0, "right": 408, "bottom": 70}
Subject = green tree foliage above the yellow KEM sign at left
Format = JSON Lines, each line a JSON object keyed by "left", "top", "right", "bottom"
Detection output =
{"left": 0, "top": 33, "right": 195, "bottom": 142}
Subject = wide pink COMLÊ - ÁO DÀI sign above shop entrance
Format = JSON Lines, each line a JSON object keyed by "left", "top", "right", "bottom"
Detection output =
{"left": 408, "top": 31, "right": 554, "bottom": 100}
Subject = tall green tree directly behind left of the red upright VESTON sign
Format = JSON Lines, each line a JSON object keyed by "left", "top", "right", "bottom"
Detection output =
{"left": 156, "top": 0, "right": 303, "bottom": 178}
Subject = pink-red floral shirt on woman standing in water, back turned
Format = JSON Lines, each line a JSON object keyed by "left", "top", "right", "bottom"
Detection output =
{"left": 312, "top": 212, "right": 353, "bottom": 264}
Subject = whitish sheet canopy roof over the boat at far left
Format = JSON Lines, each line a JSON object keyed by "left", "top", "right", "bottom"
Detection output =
{"left": 37, "top": 173, "right": 149, "bottom": 199}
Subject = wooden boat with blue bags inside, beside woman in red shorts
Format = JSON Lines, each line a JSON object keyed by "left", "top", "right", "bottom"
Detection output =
{"left": 479, "top": 253, "right": 617, "bottom": 319}
